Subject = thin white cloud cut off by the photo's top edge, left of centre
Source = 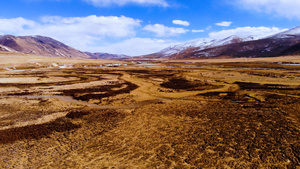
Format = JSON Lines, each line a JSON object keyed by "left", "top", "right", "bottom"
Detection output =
{"left": 84, "top": 0, "right": 169, "bottom": 7}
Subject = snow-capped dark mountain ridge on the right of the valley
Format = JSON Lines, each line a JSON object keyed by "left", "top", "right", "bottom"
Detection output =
{"left": 140, "top": 27, "right": 300, "bottom": 59}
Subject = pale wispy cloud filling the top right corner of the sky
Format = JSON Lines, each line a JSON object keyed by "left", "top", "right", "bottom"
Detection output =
{"left": 234, "top": 0, "right": 300, "bottom": 19}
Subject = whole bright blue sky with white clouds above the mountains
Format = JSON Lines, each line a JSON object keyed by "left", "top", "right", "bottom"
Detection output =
{"left": 0, "top": 0, "right": 300, "bottom": 56}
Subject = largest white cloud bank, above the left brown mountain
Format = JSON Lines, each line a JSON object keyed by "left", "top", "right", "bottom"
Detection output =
{"left": 0, "top": 15, "right": 141, "bottom": 50}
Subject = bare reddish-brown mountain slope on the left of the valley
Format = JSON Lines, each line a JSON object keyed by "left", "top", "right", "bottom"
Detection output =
{"left": 0, "top": 35, "right": 90, "bottom": 58}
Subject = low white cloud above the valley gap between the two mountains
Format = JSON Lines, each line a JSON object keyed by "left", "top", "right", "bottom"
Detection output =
{"left": 97, "top": 38, "right": 175, "bottom": 56}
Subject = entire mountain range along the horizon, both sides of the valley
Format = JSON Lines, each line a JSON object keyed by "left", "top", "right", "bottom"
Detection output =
{"left": 0, "top": 26, "right": 300, "bottom": 60}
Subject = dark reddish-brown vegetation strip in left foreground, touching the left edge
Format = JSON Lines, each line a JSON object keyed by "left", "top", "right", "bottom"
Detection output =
{"left": 0, "top": 118, "right": 80, "bottom": 144}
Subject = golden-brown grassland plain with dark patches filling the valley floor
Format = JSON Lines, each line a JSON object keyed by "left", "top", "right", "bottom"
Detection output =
{"left": 0, "top": 53, "right": 300, "bottom": 168}
